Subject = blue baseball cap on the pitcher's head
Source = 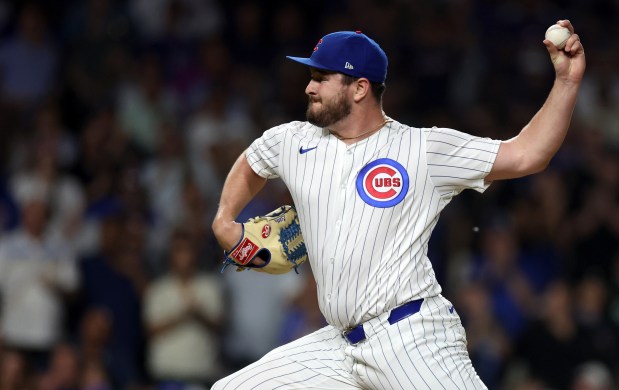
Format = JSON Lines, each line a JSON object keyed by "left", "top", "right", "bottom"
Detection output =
{"left": 286, "top": 31, "right": 387, "bottom": 83}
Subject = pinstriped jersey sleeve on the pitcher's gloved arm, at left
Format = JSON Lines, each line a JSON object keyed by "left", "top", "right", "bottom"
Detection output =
{"left": 245, "top": 125, "right": 287, "bottom": 179}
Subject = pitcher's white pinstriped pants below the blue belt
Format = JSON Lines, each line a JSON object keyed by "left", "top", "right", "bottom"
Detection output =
{"left": 213, "top": 295, "right": 486, "bottom": 390}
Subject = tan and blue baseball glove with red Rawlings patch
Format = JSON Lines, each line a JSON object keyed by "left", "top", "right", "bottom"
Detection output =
{"left": 222, "top": 206, "right": 307, "bottom": 274}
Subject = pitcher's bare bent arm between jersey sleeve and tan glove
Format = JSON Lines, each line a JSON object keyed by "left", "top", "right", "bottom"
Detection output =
{"left": 212, "top": 152, "right": 266, "bottom": 249}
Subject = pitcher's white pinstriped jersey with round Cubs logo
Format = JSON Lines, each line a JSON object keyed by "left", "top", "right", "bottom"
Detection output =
{"left": 245, "top": 121, "right": 500, "bottom": 329}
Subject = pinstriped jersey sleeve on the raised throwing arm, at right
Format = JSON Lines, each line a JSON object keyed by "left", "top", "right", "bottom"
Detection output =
{"left": 426, "top": 127, "right": 501, "bottom": 195}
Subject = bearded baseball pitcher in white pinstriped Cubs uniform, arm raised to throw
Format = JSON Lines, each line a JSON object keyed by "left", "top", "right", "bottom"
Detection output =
{"left": 213, "top": 20, "right": 585, "bottom": 389}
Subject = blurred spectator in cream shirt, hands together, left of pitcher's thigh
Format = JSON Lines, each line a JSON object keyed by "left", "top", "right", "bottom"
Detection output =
{"left": 144, "top": 229, "right": 224, "bottom": 386}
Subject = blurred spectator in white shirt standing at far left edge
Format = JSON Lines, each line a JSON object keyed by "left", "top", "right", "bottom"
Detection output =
{"left": 0, "top": 195, "right": 79, "bottom": 369}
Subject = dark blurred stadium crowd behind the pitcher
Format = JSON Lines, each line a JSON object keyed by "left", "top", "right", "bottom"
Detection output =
{"left": 0, "top": 0, "right": 619, "bottom": 390}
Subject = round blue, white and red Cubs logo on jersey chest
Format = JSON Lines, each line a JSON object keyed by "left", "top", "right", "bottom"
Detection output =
{"left": 356, "top": 158, "right": 409, "bottom": 208}
